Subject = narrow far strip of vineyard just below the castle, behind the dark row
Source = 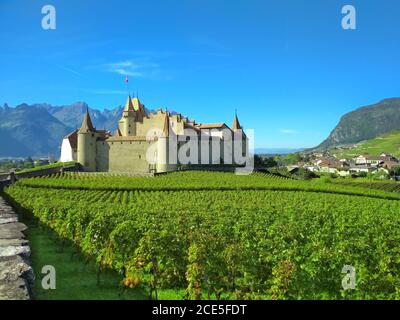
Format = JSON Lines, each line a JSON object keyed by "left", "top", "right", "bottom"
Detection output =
{"left": 11, "top": 172, "right": 400, "bottom": 200}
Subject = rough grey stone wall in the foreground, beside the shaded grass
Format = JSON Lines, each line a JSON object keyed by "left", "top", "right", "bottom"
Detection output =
{"left": 0, "top": 196, "right": 34, "bottom": 300}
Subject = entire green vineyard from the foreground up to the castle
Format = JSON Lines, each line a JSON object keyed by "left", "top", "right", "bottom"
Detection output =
{"left": 6, "top": 172, "right": 400, "bottom": 299}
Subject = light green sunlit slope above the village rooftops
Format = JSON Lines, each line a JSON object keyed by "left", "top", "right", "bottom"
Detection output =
{"left": 332, "top": 131, "right": 400, "bottom": 158}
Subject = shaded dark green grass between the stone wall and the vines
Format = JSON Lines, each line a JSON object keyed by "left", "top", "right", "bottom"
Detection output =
{"left": 24, "top": 218, "right": 148, "bottom": 300}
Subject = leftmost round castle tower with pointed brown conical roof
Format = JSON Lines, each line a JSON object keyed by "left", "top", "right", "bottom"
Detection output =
{"left": 77, "top": 110, "right": 97, "bottom": 171}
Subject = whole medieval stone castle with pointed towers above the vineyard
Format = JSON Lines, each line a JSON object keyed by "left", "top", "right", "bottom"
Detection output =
{"left": 60, "top": 96, "right": 248, "bottom": 174}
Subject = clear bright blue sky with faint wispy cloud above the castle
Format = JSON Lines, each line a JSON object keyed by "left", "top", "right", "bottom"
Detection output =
{"left": 0, "top": 0, "right": 400, "bottom": 148}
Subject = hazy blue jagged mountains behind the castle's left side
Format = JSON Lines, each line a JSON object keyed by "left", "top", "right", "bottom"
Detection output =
{"left": 0, "top": 102, "right": 123, "bottom": 158}
